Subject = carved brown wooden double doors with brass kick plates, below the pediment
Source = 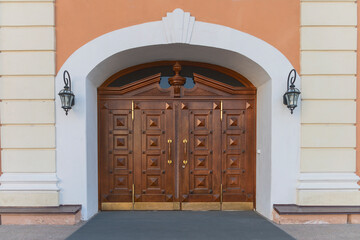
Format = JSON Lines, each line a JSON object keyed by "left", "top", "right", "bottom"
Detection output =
{"left": 99, "top": 97, "right": 255, "bottom": 210}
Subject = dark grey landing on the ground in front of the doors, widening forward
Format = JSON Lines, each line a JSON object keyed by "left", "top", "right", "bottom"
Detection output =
{"left": 67, "top": 211, "right": 294, "bottom": 240}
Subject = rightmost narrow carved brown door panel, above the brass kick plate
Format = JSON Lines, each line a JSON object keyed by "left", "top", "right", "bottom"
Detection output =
{"left": 222, "top": 100, "right": 255, "bottom": 202}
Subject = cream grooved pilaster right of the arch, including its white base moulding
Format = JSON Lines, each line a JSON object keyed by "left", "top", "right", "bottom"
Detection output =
{"left": 298, "top": 0, "right": 360, "bottom": 205}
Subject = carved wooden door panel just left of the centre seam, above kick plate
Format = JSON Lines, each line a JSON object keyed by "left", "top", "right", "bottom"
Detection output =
{"left": 134, "top": 101, "right": 175, "bottom": 207}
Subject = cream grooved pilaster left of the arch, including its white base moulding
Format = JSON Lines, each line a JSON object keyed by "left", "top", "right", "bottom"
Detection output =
{"left": 0, "top": 0, "right": 58, "bottom": 206}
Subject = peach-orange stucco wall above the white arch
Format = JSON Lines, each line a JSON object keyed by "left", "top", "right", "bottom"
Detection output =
{"left": 55, "top": 0, "right": 300, "bottom": 70}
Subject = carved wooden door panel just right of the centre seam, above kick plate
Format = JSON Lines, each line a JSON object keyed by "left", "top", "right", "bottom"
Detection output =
{"left": 178, "top": 101, "right": 221, "bottom": 202}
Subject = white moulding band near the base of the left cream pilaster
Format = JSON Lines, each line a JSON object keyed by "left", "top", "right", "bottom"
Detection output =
{"left": 0, "top": 173, "right": 59, "bottom": 191}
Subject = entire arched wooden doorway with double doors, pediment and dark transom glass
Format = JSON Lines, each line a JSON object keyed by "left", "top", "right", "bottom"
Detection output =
{"left": 98, "top": 61, "right": 256, "bottom": 210}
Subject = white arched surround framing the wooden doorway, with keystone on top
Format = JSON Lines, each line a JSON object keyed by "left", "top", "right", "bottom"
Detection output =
{"left": 56, "top": 9, "right": 300, "bottom": 220}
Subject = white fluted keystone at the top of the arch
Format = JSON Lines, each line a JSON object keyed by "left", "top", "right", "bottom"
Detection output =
{"left": 162, "top": 8, "right": 195, "bottom": 43}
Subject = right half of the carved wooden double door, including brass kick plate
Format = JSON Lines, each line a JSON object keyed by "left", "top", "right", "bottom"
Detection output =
{"left": 178, "top": 100, "right": 254, "bottom": 209}
